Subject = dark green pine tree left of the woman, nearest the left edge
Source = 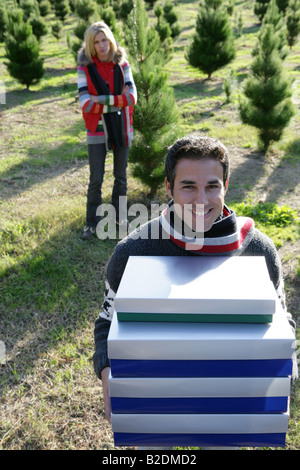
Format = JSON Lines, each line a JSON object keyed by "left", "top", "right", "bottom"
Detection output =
{"left": 5, "top": 10, "right": 45, "bottom": 89}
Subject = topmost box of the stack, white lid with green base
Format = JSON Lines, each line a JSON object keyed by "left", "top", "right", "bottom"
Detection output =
{"left": 115, "top": 256, "right": 277, "bottom": 323}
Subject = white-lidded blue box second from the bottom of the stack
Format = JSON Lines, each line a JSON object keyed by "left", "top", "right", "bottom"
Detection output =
{"left": 109, "top": 376, "right": 290, "bottom": 414}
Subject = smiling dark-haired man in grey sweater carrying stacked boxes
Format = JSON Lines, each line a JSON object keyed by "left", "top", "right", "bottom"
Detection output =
{"left": 94, "top": 136, "right": 297, "bottom": 421}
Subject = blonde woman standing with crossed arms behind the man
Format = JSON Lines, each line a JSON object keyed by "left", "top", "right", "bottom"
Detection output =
{"left": 78, "top": 21, "right": 137, "bottom": 239}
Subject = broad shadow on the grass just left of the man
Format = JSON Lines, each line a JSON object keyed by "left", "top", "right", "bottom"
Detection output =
{"left": 0, "top": 217, "right": 117, "bottom": 386}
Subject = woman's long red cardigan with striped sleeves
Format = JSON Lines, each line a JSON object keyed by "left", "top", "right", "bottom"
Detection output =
{"left": 77, "top": 48, "right": 137, "bottom": 147}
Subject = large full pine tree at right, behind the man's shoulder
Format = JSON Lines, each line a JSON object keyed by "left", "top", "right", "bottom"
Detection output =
{"left": 239, "top": 24, "right": 294, "bottom": 152}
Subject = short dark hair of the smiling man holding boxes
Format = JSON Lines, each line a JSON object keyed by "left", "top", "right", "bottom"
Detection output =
{"left": 165, "top": 135, "right": 229, "bottom": 191}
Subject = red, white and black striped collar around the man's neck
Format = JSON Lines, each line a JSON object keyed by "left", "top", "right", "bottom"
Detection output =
{"left": 160, "top": 201, "right": 254, "bottom": 256}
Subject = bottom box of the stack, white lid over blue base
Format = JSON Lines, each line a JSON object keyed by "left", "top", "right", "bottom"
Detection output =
{"left": 111, "top": 413, "right": 289, "bottom": 447}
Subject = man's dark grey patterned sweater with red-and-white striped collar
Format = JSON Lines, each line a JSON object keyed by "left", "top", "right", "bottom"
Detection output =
{"left": 93, "top": 206, "right": 298, "bottom": 379}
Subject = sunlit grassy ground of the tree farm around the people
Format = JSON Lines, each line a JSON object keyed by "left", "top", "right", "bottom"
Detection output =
{"left": 0, "top": 1, "right": 300, "bottom": 450}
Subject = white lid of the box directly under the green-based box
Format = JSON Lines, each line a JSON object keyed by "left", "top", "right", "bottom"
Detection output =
{"left": 108, "top": 302, "right": 295, "bottom": 361}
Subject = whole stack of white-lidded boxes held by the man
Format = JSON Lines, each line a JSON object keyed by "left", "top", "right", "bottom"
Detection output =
{"left": 108, "top": 256, "right": 295, "bottom": 447}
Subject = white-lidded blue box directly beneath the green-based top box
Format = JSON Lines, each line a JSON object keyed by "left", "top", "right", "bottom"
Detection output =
{"left": 108, "top": 302, "right": 295, "bottom": 377}
